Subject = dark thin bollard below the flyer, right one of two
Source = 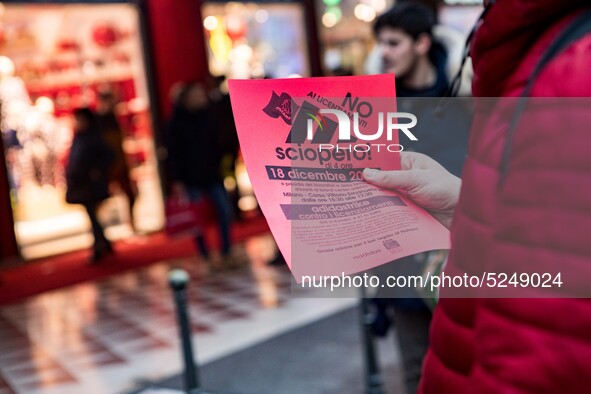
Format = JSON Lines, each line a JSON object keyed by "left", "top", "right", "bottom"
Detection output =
{"left": 359, "top": 286, "right": 385, "bottom": 394}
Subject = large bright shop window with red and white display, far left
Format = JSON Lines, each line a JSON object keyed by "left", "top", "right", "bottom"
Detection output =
{"left": 0, "top": 3, "right": 164, "bottom": 258}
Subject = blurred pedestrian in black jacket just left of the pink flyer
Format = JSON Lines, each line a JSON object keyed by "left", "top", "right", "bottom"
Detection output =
{"left": 168, "top": 82, "right": 231, "bottom": 263}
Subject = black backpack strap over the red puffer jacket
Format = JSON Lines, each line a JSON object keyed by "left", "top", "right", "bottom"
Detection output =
{"left": 499, "top": 9, "right": 591, "bottom": 185}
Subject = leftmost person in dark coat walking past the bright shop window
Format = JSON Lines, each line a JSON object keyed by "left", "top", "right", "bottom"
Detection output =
{"left": 66, "top": 108, "right": 113, "bottom": 263}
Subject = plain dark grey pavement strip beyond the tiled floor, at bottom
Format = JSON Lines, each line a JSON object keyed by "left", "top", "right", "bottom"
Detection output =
{"left": 133, "top": 307, "right": 402, "bottom": 394}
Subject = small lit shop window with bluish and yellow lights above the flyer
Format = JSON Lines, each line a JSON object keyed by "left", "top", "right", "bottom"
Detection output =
{"left": 202, "top": 2, "right": 310, "bottom": 78}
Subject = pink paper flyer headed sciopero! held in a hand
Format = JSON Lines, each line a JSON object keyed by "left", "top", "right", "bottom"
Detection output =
{"left": 229, "top": 75, "right": 450, "bottom": 282}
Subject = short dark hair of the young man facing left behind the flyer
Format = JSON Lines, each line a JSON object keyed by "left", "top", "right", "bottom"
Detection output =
{"left": 373, "top": 2, "right": 435, "bottom": 40}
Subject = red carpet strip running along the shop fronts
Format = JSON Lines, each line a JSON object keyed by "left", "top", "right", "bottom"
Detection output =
{"left": 0, "top": 216, "right": 269, "bottom": 305}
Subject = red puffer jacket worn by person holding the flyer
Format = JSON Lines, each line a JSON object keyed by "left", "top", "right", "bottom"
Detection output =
{"left": 419, "top": 0, "right": 591, "bottom": 394}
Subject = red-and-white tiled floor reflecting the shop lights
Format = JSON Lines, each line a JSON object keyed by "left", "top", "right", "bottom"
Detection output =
{"left": 0, "top": 236, "right": 354, "bottom": 394}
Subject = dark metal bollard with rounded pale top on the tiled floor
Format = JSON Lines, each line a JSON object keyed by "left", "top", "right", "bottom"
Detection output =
{"left": 168, "top": 269, "right": 200, "bottom": 394}
